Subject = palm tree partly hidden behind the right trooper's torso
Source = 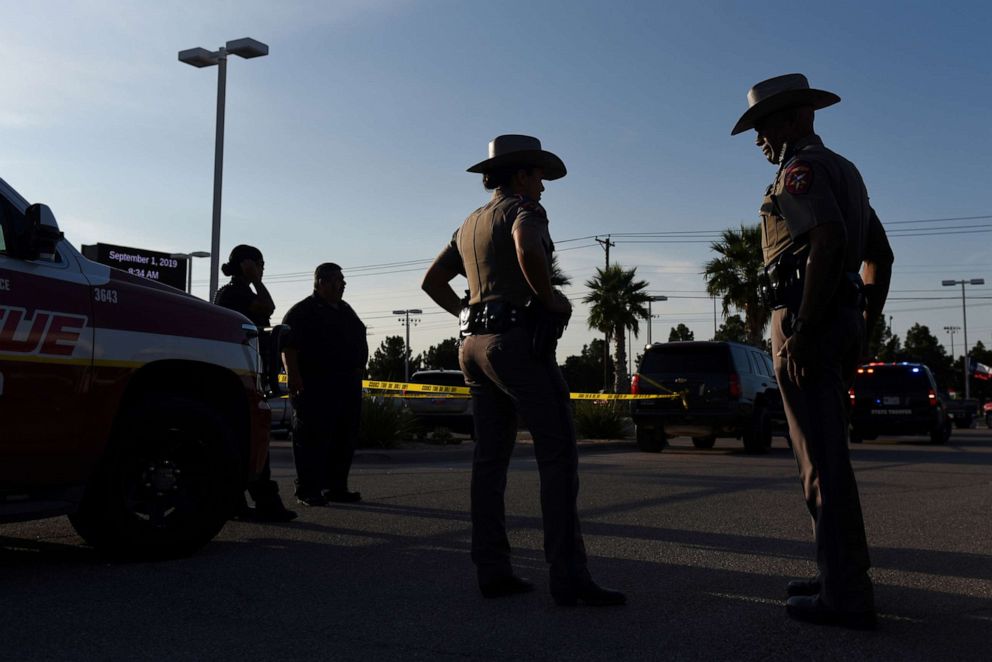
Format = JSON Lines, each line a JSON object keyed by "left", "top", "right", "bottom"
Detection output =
{"left": 703, "top": 224, "right": 771, "bottom": 346}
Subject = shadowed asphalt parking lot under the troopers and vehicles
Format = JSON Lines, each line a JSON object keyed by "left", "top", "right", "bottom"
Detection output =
{"left": 0, "top": 428, "right": 992, "bottom": 660}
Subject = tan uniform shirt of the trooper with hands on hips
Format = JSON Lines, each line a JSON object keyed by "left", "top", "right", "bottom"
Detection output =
{"left": 435, "top": 190, "right": 554, "bottom": 306}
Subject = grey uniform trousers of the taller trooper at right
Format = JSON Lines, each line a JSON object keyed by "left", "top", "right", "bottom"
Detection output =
{"left": 772, "top": 307, "right": 872, "bottom": 610}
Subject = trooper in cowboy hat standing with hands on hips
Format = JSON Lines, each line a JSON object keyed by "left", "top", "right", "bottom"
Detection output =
{"left": 422, "top": 135, "right": 626, "bottom": 606}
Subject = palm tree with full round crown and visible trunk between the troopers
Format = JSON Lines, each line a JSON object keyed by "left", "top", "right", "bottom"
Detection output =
{"left": 582, "top": 264, "right": 651, "bottom": 393}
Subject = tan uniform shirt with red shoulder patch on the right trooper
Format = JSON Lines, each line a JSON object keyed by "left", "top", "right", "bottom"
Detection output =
{"left": 760, "top": 135, "right": 875, "bottom": 272}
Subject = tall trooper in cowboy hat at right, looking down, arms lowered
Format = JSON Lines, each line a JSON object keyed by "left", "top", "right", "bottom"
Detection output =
{"left": 731, "top": 74, "right": 893, "bottom": 628}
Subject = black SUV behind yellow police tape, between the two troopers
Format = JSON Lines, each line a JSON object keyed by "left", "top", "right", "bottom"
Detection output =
{"left": 630, "top": 341, "right": 785, "bottom": 453}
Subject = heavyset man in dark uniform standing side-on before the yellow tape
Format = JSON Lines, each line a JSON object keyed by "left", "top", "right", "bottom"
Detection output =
{"left": 282, "top": 262, "right": 369, "bottom": 506}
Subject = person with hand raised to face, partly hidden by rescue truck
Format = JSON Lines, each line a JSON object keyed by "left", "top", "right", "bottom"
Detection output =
{"left": 214, "top": 244, "right": 296, "bottom": 522}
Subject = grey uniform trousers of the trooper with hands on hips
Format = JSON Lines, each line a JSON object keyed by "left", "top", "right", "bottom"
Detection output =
{"left": 459, "top": 327, "right": 588, "bottom": 582}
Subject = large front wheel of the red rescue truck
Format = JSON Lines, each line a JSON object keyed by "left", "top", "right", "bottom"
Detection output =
{"left": 69, "top": 395, "right": 243, "bottom": 560}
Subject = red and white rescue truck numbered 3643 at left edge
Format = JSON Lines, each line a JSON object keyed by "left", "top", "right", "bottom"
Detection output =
{"left": 0, "top": 179, "right": 270, "bottom": 558}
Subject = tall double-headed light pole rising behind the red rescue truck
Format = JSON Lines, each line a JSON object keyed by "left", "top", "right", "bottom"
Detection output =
{"left": 179, "top": 37, "right": 269, "bottom": 301}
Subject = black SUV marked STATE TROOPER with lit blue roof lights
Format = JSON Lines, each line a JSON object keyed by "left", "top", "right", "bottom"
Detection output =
{"left": 850, "top": 363, "right": 951, "bottom": 444}
